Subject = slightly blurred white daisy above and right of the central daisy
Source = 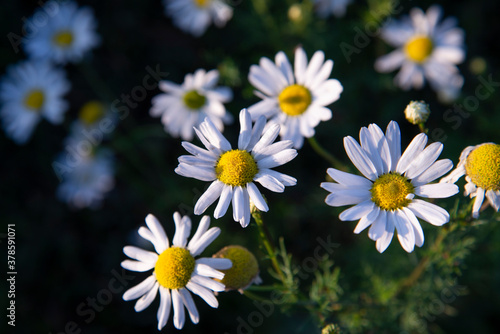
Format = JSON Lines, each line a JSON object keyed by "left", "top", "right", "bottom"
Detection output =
{"left": 248, "top": 48, "right": 343, "bottom": 148}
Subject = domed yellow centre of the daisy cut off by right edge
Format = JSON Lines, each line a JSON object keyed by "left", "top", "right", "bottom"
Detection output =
{"left": 465, "top": 144, "right": 500, "bottom": 191}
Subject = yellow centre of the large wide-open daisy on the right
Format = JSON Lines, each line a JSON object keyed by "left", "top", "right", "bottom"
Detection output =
{"left": 370, "top": 172, "right": 415, "bottom": 211}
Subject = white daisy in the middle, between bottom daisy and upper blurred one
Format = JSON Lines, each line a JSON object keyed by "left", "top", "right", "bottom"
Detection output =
{"left": 175, "top": 109, "right": 297, "bottom": 227}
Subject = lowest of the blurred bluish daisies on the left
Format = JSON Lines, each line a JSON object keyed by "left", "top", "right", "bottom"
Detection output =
{"left": 56, "top": 149, "right": 115, "bottom": 209}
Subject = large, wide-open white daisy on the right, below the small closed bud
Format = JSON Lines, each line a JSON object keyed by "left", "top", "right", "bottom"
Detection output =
{"left": 321, "top": 121, "right": 458, "bottom": 253}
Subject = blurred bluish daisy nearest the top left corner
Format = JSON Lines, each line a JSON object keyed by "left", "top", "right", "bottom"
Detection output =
{"left": 24, "top": 0, "right": 100, "bottom": 64}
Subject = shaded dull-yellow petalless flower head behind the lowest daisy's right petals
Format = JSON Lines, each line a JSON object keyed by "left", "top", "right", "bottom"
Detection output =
{"left": 213, "top": 245, "right": 259, "bottom": 291}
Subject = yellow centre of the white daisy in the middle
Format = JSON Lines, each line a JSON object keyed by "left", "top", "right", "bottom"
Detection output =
{"left": 215, "top": 150, "right": 259, "bottom": 186}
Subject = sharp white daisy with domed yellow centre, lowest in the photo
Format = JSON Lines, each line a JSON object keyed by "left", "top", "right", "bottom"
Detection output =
{"left": 122, "top": 212, "right": 232, "bottom": 330}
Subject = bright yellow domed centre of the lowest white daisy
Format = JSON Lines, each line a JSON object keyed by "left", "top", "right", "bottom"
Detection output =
{"left": 155, "top": 247, "right": 195, "bottom": 289}
